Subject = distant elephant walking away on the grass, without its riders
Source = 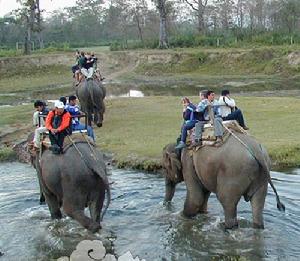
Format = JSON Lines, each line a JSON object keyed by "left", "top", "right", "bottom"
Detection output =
{"left": 76, "top": 79, "right": 106, "bottom": 127}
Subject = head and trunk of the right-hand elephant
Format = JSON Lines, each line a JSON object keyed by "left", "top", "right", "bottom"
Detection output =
{"left": 162, "top": 143, "right": 183, "bottom": 202}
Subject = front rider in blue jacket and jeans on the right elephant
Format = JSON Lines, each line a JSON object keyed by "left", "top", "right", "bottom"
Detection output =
{"left": 175, "top": 97, "right": 198, "bottom": 149}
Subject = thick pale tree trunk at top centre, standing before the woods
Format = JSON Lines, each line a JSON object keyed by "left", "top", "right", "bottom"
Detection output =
{"left": 157, "top": 0, "right": 169, "bottom": 49}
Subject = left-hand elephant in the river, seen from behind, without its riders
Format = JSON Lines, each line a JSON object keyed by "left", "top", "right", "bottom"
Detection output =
{"left": 35, "top": 140, "right": 110, "bottom": 232}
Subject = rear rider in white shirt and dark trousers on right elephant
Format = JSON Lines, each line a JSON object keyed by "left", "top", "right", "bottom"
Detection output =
{"left": 219, "top": 90, "right": 249, "bottom": 130}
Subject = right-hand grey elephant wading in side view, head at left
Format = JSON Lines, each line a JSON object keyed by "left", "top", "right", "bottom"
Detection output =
{"left": 162, "top": 134, "right": 285, "bottom": 229}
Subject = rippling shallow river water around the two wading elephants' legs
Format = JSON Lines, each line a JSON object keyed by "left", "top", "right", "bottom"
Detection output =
{"left": 0, "top": 163, "right": 300, "bottom": 261}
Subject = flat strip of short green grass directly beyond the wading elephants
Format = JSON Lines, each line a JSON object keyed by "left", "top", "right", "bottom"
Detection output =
{"left": 0, "top": 96, "right": 300, "bottom": 171}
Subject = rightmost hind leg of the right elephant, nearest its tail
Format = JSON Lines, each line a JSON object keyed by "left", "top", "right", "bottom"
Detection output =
{"left": 251, "top": 183, "right": 268, "bottom": 229}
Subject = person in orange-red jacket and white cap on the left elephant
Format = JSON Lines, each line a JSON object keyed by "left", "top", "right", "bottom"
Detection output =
{"left": 45, "top": 101, "right": 71, "bottom": 154}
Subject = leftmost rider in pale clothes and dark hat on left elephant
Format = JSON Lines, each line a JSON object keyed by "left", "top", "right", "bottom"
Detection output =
{"left": 33, "top": 100, "right": 49, "bottom": 150}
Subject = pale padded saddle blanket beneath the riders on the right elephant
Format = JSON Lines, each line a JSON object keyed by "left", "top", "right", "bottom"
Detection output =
{"left": 187, "top": 120, "right": 248, "bottom": 149}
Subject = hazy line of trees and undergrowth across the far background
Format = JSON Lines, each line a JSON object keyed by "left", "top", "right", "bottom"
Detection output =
{"left": 0, "top": 0, "right": 300, "bottom": 53}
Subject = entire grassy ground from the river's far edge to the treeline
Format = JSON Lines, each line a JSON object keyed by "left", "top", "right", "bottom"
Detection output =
{"left": 0, "top": 46, "right": 300, "bottom": 170}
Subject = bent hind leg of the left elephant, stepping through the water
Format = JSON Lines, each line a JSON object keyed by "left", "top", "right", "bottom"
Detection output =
{"left": 63, "top": 191, "right": 101, "bottom": 233}
